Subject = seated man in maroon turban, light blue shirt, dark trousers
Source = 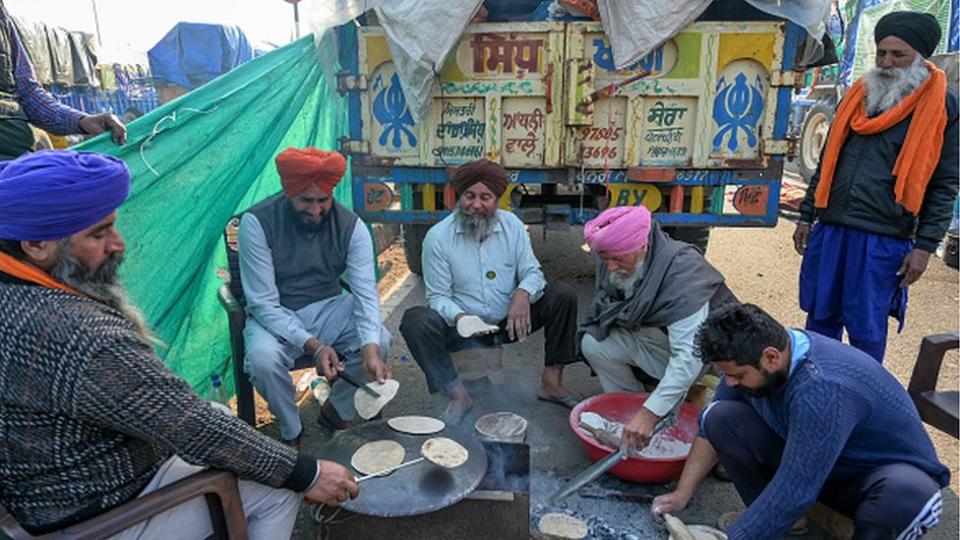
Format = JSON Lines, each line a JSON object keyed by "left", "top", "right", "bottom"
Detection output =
{"left": 400, "top": 159, "right": 579, "bottom": 424}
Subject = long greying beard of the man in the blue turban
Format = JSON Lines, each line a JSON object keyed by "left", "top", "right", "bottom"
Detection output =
{"left": 50, "top": 239, "right": 161, "bottom": 345}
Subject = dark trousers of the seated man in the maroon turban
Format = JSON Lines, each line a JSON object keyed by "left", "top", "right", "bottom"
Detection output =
{"left": 400, "top": 282, "right": 577, "bottom": 393}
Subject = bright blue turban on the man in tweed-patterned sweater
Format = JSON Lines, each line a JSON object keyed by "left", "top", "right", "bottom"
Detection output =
{"left": 0, "top": 150, "right": 130, "bottom": 241}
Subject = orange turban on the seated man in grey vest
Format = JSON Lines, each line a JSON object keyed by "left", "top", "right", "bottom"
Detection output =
{"left": 275, "top": 146, "right": 347, "bottom": 198}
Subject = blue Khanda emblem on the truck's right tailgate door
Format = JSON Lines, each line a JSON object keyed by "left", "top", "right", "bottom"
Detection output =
{"left": 713, "top": 73, "right": 763, "bottom": 152}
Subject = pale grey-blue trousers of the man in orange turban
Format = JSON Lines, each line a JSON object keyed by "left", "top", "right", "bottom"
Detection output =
{"left": 243, "top": 294, "right": 391, "bottom": 440}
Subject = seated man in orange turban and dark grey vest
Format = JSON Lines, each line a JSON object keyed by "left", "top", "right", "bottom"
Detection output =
{"left": 238, "top": 148, "right": 391, "bottom": 445}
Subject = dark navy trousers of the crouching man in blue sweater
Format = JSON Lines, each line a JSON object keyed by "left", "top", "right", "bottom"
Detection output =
{"left": 704, "top": 401, "right": 940, "bottom": 540}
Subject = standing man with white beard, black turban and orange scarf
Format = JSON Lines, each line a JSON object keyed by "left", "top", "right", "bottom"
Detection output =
{"left": 793, "top": 11, "right": 960, "bottom": 362}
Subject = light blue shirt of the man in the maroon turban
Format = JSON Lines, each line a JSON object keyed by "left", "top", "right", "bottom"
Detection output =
{"left": 423, "top": 210, "right": 547, "bottom": 326}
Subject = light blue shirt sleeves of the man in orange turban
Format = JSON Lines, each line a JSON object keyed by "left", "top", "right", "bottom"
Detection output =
{"left": 239, "top": 212, "right": 381, "bottom": 349}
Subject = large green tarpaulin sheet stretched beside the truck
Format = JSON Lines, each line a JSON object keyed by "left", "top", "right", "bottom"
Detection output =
{"left": 75, "top": 37, "right": 352, "bottom": 393}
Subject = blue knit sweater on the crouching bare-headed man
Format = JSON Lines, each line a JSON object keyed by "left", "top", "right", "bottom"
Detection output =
{"left": 714, "top": 332, "right": 950, "bottom": 540}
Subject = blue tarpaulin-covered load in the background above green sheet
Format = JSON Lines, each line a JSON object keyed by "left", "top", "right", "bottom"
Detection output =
{"left": 147, "top": 22, "right": 253, "bottom": 90}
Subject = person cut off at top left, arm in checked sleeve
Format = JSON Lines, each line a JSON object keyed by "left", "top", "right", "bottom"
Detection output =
{"left": 0, "top": 0, "right": 127, "bottom": 161}
